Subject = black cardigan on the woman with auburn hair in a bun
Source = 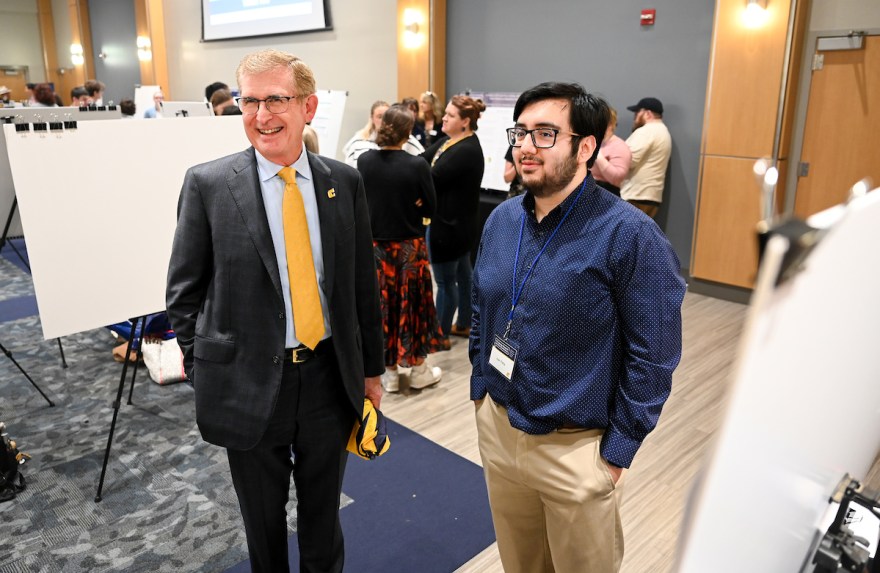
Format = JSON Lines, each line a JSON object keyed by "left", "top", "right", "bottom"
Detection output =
{"left": 422, "top": 135, "right": 485, "bottom": 263}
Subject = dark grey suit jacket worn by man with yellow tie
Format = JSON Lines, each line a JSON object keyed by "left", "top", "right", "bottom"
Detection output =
{"left": 166, "top": 148, "right": 385, "bottom": 450}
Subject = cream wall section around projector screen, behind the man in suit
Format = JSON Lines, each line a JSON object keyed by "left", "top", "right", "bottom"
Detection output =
{"left": 165, "top": 0, "right": 397, "bottom": 161}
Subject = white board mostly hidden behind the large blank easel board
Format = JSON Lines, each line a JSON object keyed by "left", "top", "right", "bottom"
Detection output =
{"left": 0, "top": 107, "right": 122, "bottom": 237}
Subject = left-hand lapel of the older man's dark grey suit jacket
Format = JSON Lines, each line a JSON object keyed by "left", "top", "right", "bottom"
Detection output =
{"left": 226, "top": 148, "right": 284, "bottom": 300}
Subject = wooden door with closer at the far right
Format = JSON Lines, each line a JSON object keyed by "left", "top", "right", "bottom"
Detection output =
{"left": 794, "top": 36, "right": 880, "bottom": 217}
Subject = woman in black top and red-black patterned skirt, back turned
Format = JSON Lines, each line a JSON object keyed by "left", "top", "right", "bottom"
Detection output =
{"left": 357, "top": 105, "right": 442, "bottom": 392}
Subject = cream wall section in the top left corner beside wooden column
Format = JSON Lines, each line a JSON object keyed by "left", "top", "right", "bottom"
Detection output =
{"left": 0, "top": 0, "right": 46, "bottom": 84}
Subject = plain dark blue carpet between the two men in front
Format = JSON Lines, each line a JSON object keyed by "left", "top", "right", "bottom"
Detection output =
{"left": 227, "top": 420, "right": 495, "bottom": 573}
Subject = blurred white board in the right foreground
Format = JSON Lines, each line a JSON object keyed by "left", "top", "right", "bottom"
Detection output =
{"left": 676, "top": 191, "right": 880, "bottom": 573}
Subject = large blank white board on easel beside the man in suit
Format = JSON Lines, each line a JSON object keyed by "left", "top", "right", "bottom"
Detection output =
{"left": 3, "top": 116, "right": 250, "bottom": 339}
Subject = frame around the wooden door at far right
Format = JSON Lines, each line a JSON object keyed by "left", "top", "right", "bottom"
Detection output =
{"left": 784, "top": 28, "right": 880, "bottom": 215}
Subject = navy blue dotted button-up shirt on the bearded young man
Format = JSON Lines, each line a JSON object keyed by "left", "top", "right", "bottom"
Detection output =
{"left": 470, "top": 175, "right": 685, "bottom": 467}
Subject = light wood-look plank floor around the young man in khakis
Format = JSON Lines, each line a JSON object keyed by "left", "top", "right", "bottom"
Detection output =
{"left": 382, "top": 293, "right": 746, "bottom": 573}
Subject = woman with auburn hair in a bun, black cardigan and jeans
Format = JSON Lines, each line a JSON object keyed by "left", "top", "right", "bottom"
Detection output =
{"left": 423, "top": 95, "right": 486, "bottom": 348}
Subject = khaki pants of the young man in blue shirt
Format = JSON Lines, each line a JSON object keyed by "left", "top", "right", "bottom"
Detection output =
{"left": 476, "top": 395, "right": 623, "bottom": 573}
